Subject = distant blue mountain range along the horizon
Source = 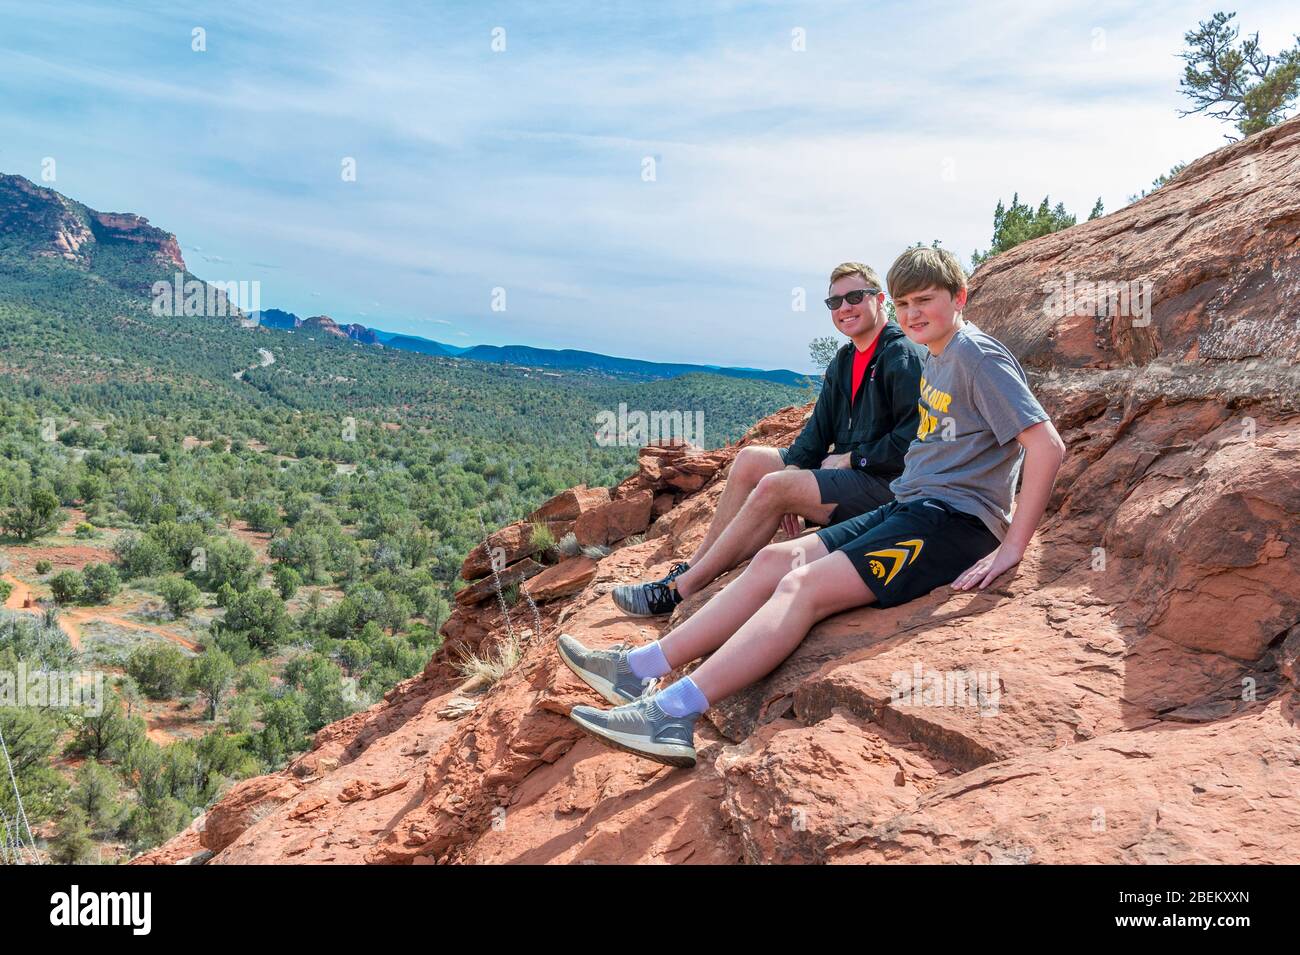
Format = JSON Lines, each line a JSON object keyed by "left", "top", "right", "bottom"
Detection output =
{"left": 252, "top": 308, "right": 809, "bottom": 385}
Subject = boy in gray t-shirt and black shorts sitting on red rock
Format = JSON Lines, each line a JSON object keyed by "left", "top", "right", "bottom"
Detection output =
{"left": 559, "top": 248, "right": 1065, "bottom": 767}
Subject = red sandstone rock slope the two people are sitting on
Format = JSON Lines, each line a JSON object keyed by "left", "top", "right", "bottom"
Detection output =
{"left": 135, "top": 113, "right": 1300, "bottom": 864}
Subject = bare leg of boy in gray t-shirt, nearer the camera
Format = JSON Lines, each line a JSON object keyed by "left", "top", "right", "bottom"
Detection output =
{"left": 690, "top": 551, "right": 876, "bottom": 703}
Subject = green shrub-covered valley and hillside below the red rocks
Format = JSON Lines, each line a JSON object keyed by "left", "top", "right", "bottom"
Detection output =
{"left": 0, "top": 192, "right": 806, "bottom": 860}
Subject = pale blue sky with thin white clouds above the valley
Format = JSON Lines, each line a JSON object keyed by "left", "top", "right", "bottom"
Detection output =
{"left": 0, "top": 0, "right": 1300, "bottom": 370}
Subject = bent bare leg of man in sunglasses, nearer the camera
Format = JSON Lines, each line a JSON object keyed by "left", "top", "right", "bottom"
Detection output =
{"left": 677, "top": 470, "right": 836, "bottom": 596}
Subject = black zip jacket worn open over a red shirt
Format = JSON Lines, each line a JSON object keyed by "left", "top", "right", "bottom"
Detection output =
{"left": 785, "top": 322, "right": 926, "bottom": 481}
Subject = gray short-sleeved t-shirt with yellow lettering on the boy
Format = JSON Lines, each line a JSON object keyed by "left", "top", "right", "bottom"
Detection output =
{"left": 889, "top": 322, "right": 1048, "bottom": 541}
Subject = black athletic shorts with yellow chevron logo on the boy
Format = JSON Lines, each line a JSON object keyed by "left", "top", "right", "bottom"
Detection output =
{"left": 816, "top": 498, "right": 998, "bottom": 607}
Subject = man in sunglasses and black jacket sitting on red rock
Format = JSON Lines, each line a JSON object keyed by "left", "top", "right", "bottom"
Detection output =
{"left": 614, "top": 262, "right": 926, "bottom": 616}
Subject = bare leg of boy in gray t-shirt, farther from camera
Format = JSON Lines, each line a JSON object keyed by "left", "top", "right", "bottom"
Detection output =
{"left": 659, "top": 534, "right": 827, "bottom": 669}
